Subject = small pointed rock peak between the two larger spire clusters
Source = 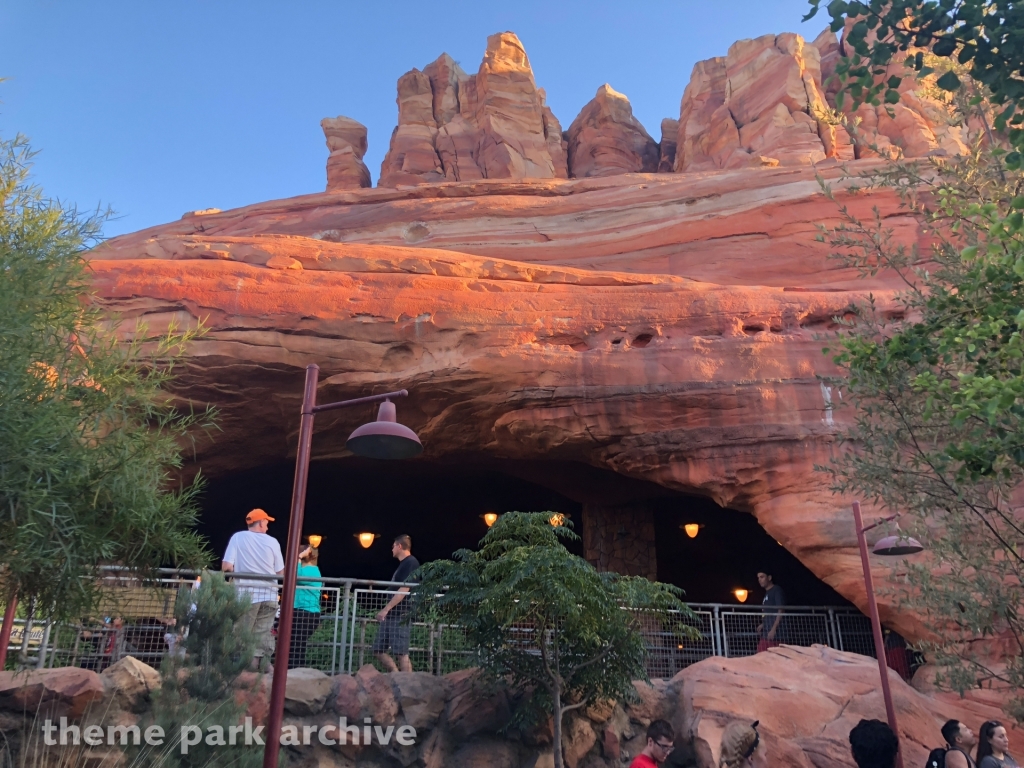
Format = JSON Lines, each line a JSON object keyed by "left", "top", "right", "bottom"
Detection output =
{"left": 568, "top": 83, "right": 660, "bottom": 178}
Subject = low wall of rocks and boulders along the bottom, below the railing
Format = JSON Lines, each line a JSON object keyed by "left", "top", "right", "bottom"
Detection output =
{"left": 0, "top": 646, "right": 1024, "bottom": 768}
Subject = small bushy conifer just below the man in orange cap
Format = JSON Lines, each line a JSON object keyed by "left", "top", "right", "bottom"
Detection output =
{"left": 141, "top": 571, "right": 268, "bottom": 768}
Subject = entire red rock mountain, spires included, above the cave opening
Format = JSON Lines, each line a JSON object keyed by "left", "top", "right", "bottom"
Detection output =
{"left": 83, "top": 22, "right": 978, "bottom": 638}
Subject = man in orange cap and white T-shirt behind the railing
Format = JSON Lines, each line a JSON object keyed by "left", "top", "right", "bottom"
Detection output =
{"left": 220, "top": 509, "right": 285, "bottom": 672}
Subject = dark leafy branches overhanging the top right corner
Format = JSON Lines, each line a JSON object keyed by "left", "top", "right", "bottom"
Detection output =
{"left": 804, "top": 0, "right": 1024, "bottom": 169}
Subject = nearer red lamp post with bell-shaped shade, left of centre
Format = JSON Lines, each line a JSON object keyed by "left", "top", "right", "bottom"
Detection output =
{"left": 263, "top": 365, "right": 423, "bottom": 768}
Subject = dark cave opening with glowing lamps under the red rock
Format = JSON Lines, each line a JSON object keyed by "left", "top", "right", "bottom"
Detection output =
{"left": 200, "top": 457, "right": 850, "bottom": 605}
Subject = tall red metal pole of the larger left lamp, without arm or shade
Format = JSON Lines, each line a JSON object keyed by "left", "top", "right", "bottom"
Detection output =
{"left": 263, "top": 365, "right": 319, "bottom": 768}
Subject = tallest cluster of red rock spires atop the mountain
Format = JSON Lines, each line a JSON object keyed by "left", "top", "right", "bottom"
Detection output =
{"left": 379, "top": 32, "right": 566, "bottom": 186}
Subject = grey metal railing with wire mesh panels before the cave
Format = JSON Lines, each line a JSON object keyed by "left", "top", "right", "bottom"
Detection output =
{"left": 4, "top": 569, "right": 874, "bottom": 678}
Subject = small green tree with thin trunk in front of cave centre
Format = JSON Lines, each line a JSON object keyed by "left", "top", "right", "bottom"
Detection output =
{"left": 416, "top": 512, "right": 698, "bottom": 768}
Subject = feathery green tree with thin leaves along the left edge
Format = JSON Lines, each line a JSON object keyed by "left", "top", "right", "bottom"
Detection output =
{"left": 0, "top": 136, "right": 209, "bottom": 638}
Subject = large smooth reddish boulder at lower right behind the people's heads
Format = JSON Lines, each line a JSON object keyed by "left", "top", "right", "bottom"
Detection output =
{"left": 670, "top": 645, "right": 1024, "bottom": 768}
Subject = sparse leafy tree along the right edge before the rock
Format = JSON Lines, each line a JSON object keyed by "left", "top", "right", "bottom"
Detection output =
{"left": 822, "top": 151, "right": 1024, "bottom": 720}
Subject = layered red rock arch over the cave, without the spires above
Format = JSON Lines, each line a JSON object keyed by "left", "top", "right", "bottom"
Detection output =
{"left": 92, "top": 165, "right": 933, "bottom": 637}
